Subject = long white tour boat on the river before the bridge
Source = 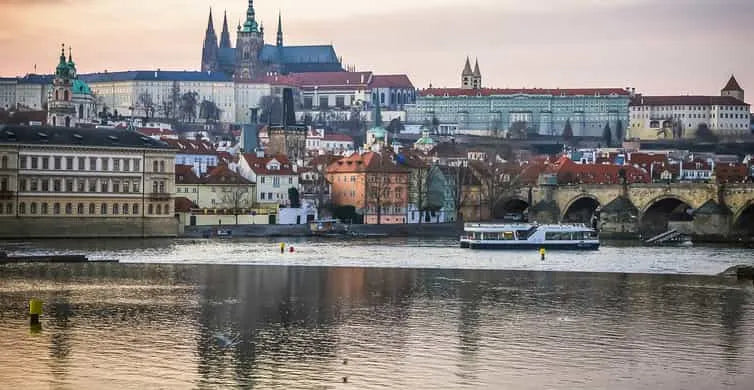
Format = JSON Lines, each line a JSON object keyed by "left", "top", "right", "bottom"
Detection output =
{"left": 461, "top": 223, "right": 600, "bottom": 250}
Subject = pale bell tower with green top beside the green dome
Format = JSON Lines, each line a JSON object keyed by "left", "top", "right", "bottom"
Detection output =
{"left": 47, "top": 45, "right": 76, "bottom": 127}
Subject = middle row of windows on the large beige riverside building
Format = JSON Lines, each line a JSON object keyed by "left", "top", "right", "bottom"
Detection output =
{"left": 14, "top": 177, "right": 141, "bottom": 193}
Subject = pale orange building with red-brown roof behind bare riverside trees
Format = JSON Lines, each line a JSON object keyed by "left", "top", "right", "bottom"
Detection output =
{"left": 327, "top": 152, "right": 409, "bottom": 224}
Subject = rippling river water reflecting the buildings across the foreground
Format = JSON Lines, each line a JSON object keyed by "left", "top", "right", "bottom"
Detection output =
{"left": 0, "top": 239, "right": 754, "bottom": 389}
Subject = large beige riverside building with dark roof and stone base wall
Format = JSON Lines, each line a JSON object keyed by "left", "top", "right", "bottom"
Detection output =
{"left": 0, "top": 126, "right": 178, "bottom": 237}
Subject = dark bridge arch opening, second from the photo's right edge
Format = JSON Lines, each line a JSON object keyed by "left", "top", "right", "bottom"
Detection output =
{"left": 639, "top": 194, "right": 694, "bottom": 236}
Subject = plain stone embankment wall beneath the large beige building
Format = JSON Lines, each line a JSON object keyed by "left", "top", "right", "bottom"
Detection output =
{"left": 0, "top": 217, "right": 179, "bottom": 238}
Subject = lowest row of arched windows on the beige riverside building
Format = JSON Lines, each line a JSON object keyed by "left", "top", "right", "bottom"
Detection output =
{"left": 0, "top": 202, "right": 170, "bottom": 216}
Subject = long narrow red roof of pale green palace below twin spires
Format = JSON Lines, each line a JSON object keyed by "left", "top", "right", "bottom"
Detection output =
{"left": 419, "top": 88, "right": 629, "bottom": 97}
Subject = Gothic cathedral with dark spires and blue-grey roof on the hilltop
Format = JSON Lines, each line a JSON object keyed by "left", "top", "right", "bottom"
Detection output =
{"left": 202, "top": 0, "right": 343, "bottom": 81}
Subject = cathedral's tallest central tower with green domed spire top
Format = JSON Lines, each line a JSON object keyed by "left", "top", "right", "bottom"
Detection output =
{"left": 238, "top": 0, "right": 265, "bottom": 80}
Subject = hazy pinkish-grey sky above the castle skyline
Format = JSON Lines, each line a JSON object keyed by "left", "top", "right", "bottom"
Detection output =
{"left": 0, "top": 0, "right": 754, "bottom": 95}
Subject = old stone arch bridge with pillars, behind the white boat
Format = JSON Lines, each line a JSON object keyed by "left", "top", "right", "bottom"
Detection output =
{"left": 501, "top": 183, "right": 754, "bottom": 238}
